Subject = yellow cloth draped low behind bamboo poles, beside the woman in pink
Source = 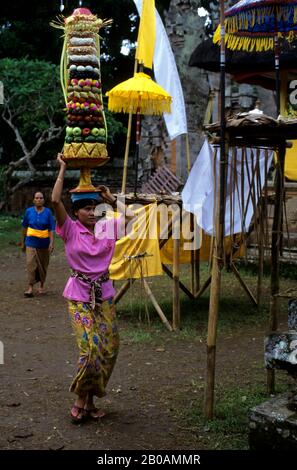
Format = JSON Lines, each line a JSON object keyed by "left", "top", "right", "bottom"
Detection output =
{"left": 110, "top": 204, "right": 245, "bottom": 280}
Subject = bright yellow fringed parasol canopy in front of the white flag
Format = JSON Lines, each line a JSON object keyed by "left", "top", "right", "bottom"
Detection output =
{"left": 107, "top": 72, "right": 172, "bottom": 115}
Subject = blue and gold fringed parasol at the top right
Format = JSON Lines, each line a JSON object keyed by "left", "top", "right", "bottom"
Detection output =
{"left": 214, "top": 0, "right": 297, "bottom": 114}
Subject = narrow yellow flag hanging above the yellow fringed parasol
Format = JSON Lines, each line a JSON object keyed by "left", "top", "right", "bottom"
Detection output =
{"left": 136, "top": 0, "right": 156, "bottom": 69}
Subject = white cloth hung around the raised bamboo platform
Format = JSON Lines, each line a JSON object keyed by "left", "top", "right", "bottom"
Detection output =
{"left": 182, "top": 140, "right": 273, "bottom": 236}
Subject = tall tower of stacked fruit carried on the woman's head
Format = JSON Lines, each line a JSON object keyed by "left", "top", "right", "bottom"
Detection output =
{"left": 53, "top": 8, "right": 110, "bottom": 167}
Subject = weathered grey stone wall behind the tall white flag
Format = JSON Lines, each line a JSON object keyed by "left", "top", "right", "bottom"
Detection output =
{"left": 139, "top": 0, "right": 209, "bottom": 187}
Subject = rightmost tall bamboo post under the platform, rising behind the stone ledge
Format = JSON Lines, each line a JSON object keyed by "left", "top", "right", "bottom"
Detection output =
{"left": 267, "top": 142, "right": 286, "bottom": 394}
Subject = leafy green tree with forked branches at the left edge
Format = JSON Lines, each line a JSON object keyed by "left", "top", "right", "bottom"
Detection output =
{"left": 0, "top": 59, "right": 63, "bottom": 208}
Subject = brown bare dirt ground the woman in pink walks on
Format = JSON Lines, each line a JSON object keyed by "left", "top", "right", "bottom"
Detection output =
{"left": 0, "top": 251, "right": 263, "bottom": 450}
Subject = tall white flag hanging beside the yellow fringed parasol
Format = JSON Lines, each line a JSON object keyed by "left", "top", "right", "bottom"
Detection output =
{"left": 134, "top": 0, "right": 188, "bottom": 140}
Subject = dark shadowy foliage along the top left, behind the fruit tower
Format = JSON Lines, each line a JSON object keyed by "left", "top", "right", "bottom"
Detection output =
{"left": 0, "top": 0, "right": 170, "bottom": 86}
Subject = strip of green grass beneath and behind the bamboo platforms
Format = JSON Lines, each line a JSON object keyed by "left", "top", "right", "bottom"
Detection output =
{"left": 116, "top": 263, "right": 297, "bottom": 340}
